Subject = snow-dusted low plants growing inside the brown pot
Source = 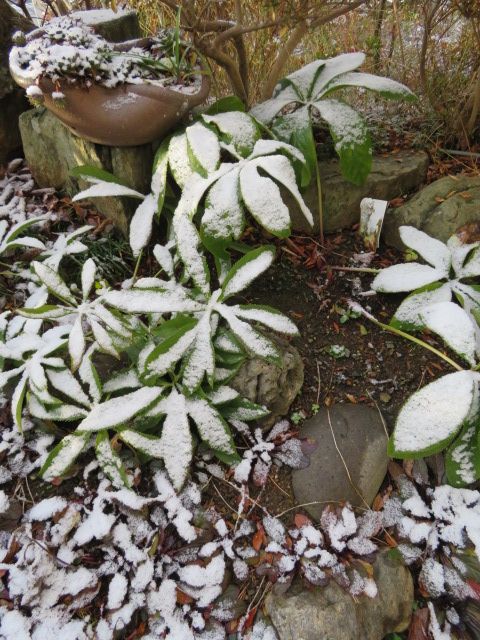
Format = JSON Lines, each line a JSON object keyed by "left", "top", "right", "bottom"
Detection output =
{"left": 10, "top": 16, "right": 199, "bottom": 92}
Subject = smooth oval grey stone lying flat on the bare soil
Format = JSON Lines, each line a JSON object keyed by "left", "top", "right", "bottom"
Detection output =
{"left": 292, "top": 404, "right": 388, "bottom": 519}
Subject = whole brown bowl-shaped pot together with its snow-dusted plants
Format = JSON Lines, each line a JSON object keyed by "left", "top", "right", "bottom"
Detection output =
{"left": 10, "top": 17, "right": 210, "bottom": 146}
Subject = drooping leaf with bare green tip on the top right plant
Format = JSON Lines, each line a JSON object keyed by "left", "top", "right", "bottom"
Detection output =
{"left": 313, "top": 100, "right": 372, "bottom": 185}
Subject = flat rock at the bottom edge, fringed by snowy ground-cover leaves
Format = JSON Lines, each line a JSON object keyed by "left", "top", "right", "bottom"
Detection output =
{"left": 265, "top": 551, "right": 413, "bottom": 640}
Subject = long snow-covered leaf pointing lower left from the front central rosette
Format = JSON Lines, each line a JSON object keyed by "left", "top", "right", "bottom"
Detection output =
{"left": 78, "top": 387, "right": 163, "bottom": 431}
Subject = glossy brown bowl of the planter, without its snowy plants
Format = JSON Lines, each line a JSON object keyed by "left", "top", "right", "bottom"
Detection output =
{"left": 12, "top": 74, "right": 210, "bottom": 147}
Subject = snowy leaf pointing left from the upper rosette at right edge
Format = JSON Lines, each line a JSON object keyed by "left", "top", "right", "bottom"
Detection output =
{"left": 372, "top": 262, "right": 444, "bottom": 293}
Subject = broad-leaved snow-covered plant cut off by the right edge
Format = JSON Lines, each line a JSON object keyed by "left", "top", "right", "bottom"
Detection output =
{"left": 372, "top": 226, "right": 480, "bottom": 486}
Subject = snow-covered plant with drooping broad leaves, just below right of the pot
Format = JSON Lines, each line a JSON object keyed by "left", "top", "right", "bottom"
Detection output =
{"left": 70, "top": 111, "right": 313, "bottom": 259}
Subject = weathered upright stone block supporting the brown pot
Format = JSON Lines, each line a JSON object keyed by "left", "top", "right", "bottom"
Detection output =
{"left": 19, "top": 107, "right": 156, "bottom": 234}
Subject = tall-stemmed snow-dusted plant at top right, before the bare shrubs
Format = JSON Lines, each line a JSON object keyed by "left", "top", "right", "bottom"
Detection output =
{"left": 251, "top": 53, "right": 415, "bottom": 184}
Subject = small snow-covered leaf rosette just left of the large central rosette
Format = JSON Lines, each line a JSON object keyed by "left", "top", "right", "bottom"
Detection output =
{"left": 18, "top": 258, "right": 132, "bottom": 369}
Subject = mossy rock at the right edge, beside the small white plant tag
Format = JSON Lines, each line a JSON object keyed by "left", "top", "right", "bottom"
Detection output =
{"left": 382, "top": 175, "right": 480, "bottom": 249}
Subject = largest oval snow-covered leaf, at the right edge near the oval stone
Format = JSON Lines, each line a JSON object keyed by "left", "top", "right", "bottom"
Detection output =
{"left": 389, "top": 371, "right": 478, "bottom": 458}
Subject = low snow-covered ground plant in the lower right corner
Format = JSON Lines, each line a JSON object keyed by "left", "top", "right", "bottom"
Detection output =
{"left": 383, "top": 476, "right": 480, "bottom": 601}
